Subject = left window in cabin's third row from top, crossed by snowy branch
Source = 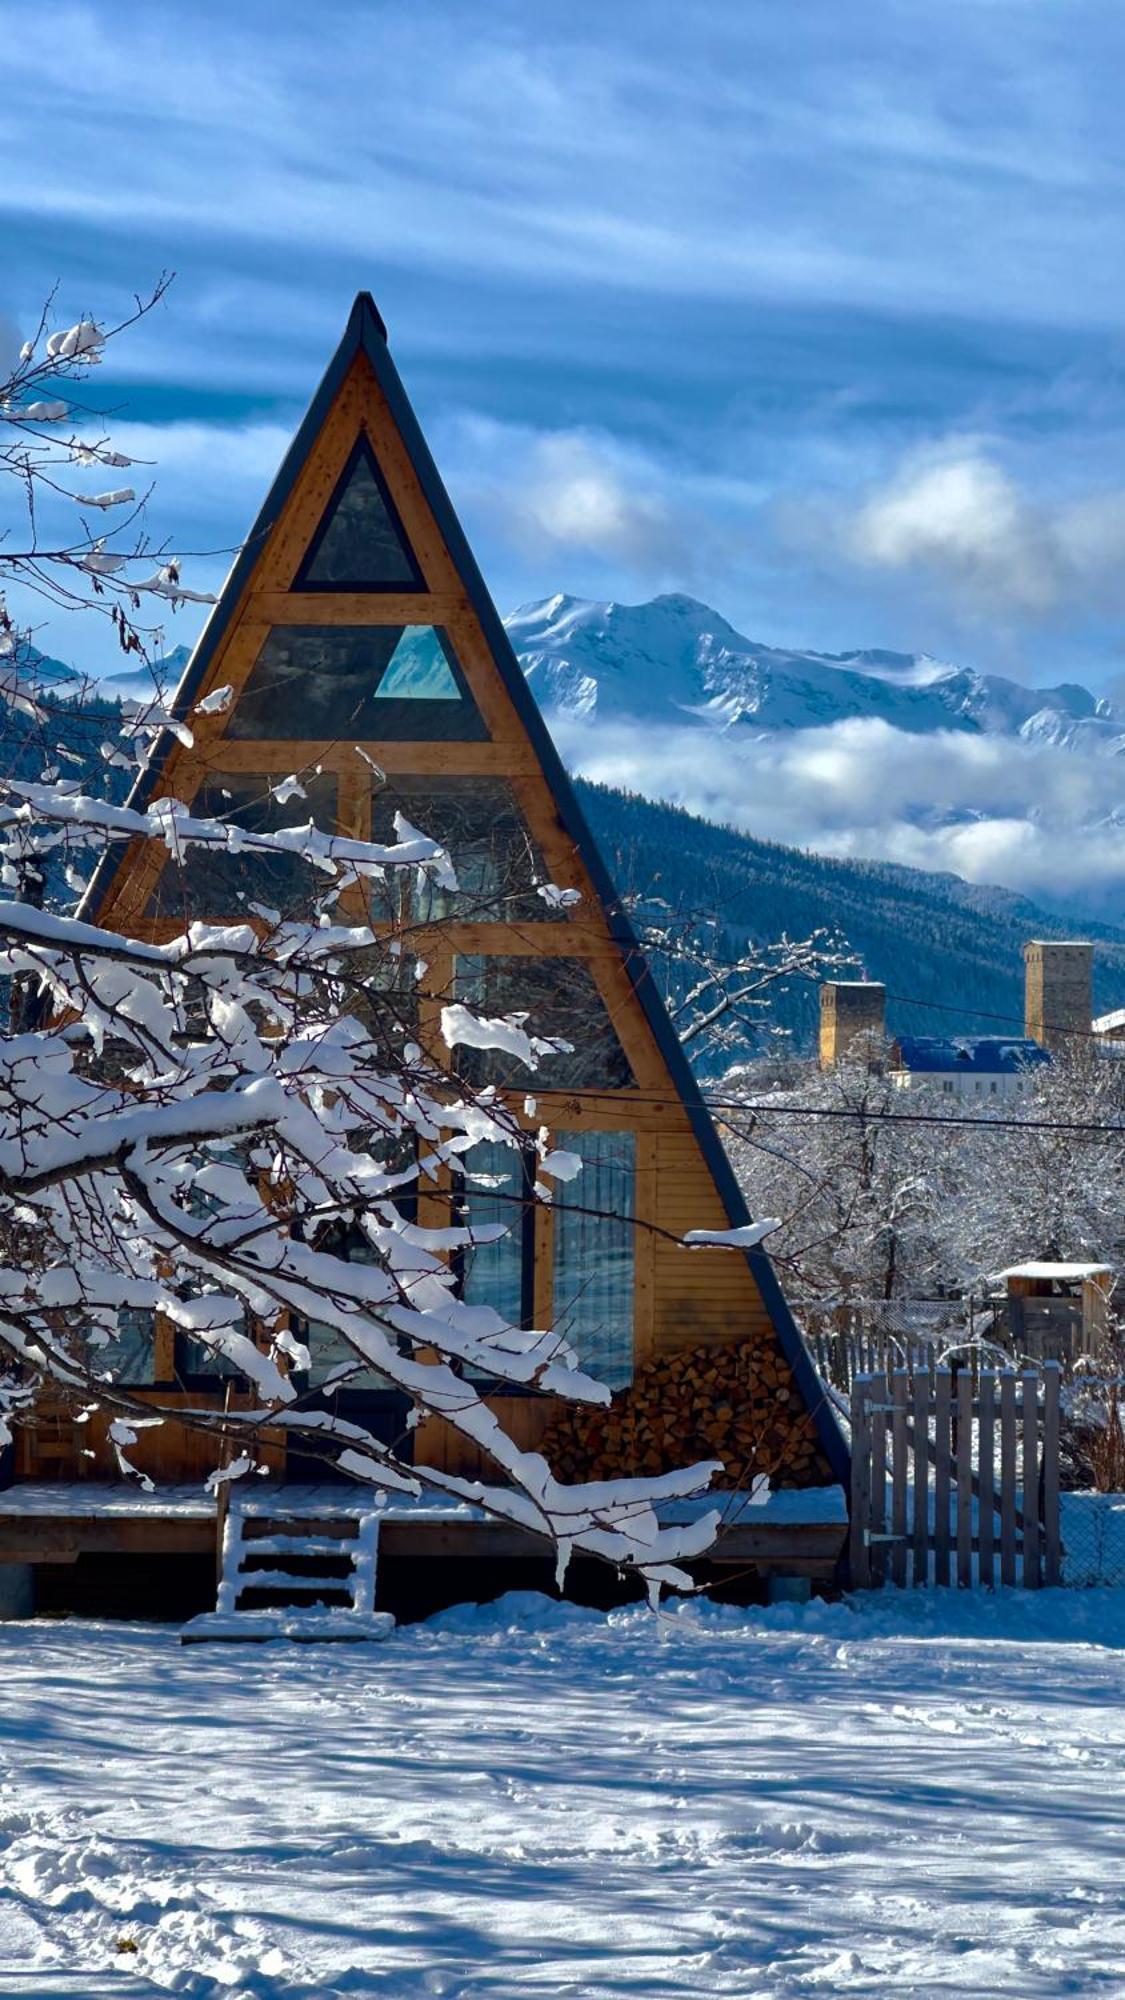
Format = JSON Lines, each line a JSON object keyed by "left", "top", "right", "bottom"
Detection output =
{"left": 146, "top": 772, "right": 336, "bottom": 920}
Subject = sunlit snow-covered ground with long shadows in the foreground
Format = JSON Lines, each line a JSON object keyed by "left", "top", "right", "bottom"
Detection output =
{"left": 0, "top": 1590, "right": 1125, "bottom": 2000}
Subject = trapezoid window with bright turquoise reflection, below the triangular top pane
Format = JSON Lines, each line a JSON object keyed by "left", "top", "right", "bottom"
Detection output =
{"left": 226, "top": 626, "right": 488, "bottom": 742}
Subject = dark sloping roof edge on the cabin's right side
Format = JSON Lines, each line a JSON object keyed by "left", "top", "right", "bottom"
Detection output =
{"left": 354, "top": 304, "right": 851, "bottom": 1488}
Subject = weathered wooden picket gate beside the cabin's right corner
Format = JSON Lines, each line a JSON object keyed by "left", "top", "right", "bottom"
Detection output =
{"left": 851, "top": 1362, "right": 1061, "bottom": 1590}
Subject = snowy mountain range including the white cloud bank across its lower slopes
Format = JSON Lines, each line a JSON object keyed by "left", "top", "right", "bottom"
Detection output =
{"left": 506, "top": 596, "right": 1125, "bottom": 922}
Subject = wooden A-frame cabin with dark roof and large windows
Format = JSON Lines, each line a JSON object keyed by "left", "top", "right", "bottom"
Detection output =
{"left": 20, "top": 294, "right": 847, "bottom": 1544}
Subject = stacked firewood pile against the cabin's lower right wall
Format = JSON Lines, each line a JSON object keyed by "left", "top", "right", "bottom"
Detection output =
{"left": 542, "top": 1342, "right": 831, "bottom": 1488}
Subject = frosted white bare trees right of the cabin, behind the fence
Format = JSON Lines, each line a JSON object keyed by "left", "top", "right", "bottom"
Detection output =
{"left": 719, "top": 1038, "right": 1125, "bottom": 1302}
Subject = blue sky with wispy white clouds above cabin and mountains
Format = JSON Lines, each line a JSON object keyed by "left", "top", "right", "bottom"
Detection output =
{"left": 0, "top": 0, "right": 1125, "bottom": 684}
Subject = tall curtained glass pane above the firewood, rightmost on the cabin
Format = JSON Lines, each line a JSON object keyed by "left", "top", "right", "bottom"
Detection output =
{"left": 552, "top": 1132, "right": 637, "bottom": 1388}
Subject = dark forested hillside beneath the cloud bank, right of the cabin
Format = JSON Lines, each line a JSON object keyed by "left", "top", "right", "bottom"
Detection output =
{"left": 577, "top": 782, "right": 1125, "bottom": 1042}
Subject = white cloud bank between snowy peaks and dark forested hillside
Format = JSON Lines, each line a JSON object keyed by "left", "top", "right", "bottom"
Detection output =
{"left": 550, "top": 718, "right": 1125, "bottom": 918}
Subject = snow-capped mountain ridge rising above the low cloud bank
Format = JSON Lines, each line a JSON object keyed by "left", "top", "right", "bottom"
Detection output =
{"left": 504, "top": 594, "right": 1125, "bottom": 752}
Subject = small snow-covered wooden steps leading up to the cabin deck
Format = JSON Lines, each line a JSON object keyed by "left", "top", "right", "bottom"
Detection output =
{"left": 180, "top": 1488, "right": 394, "bottom": 1646}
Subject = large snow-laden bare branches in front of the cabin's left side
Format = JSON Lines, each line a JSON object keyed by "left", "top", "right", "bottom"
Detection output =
{"left": 0, "top": 780, "right": 717, "bottom": 1582}
